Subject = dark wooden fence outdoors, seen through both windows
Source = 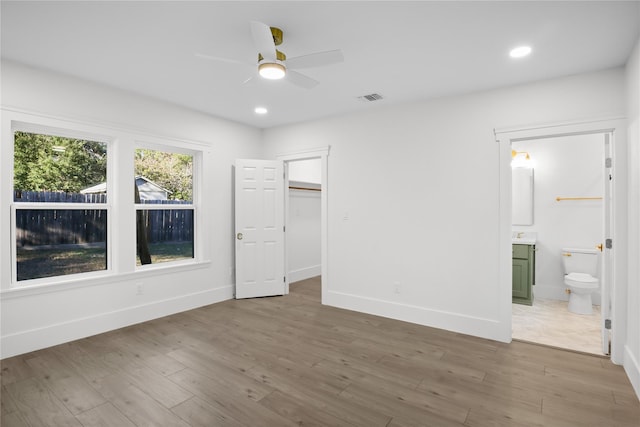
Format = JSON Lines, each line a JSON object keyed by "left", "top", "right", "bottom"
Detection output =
{"left": 14, "top": 191, "right": 193, "bottom": 247}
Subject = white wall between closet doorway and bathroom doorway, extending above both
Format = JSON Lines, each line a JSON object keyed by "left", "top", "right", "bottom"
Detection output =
{"left": 263, "top": 69, "right": 625, "bottom": 341}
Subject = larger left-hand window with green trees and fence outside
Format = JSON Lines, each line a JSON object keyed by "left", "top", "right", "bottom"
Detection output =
{"left": 12, "top": 131, "right": 109, "bottom": 282}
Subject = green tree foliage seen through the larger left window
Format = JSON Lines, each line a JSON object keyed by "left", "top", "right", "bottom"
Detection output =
{"left": 13, "top": 132, "right": 107, "bottom": 193}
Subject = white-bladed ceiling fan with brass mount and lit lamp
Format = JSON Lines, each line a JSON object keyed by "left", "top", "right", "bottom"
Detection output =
{"left": 196, "top": 21, "right": 344, "bottom": 89}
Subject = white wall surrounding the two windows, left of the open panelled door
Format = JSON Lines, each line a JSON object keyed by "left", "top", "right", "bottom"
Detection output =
{"left": 0, "top": 62, "right": 262, "bottom": 357}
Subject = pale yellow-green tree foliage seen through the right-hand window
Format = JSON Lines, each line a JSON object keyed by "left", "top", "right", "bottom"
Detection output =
{"left": 134, "top": 149, "right": 193, "bottom": 201}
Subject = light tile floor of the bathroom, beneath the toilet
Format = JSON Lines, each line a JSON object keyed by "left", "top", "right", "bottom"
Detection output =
{"left": 511, "top": 298, "right": 603, "bottom": 355}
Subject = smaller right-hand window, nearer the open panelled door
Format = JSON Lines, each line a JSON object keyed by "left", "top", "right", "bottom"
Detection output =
{"left": 134, "top": 148, "right": 195, "bottom": 266}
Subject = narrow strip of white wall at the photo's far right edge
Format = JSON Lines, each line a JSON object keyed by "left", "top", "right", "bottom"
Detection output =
{"left": 624, "top": 40, "right": 640, "bottom": 402}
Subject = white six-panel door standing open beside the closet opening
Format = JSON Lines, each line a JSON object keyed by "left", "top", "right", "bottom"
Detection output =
{"left": 235, "top": 160, "right": 285, "bottom": 299}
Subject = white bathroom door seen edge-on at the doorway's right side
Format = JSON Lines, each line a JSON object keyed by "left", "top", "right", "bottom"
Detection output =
{"left": 600, "top": 133, "right": 614, "bottom": 354}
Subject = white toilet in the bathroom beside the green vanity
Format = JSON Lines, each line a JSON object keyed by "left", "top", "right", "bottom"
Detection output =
{"left": 562, "top": 248, "right": 600, "bottom": 314}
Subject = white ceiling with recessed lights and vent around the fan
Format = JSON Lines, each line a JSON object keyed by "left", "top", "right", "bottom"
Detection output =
{"left": 1, "top": 0, "right": 640, "bottom": 128}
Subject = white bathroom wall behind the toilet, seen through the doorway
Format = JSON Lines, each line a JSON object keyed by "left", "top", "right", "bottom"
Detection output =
{"left": 512, "top": 134, "right": 604, "bottom": 305}
